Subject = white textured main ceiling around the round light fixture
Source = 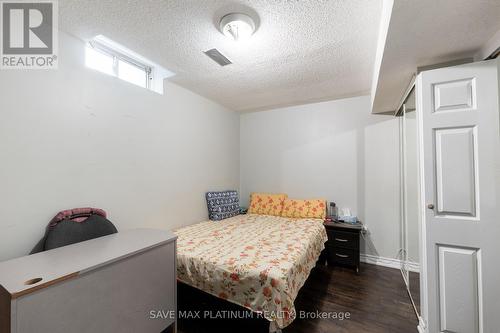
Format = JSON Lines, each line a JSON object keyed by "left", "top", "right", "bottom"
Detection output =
{"left": 59, "top": 0, "right": 382, "bottom": 111}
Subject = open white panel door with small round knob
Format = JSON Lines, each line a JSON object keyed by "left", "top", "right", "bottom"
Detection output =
{"left": 417, "top": 60, "right": 500, "bottom": 333}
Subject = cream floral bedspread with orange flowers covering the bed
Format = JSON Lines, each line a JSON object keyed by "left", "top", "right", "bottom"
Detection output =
{"left": 175, "top": 214, "right": 327, "bottom": 328}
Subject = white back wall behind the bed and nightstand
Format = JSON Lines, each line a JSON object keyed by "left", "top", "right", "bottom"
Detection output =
{"left": 240, "top": 96, "right": 400, "bottom": 258}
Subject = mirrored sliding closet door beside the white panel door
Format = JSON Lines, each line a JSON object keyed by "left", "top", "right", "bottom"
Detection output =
{"left": 398, "top": 88, "right": 420, "bottom": 316}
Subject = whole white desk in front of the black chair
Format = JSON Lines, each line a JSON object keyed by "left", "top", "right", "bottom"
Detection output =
{"left": 0, "top": 229, "right": 177, "bottom": 333}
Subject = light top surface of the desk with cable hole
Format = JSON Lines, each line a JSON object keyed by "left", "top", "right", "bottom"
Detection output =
{"left": 0, "top": 229, "right": 177, "bottom": 298}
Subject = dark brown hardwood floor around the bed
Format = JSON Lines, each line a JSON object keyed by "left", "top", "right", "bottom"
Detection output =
{"left": 178, "top": 264, "right": 418, "bottom": 333}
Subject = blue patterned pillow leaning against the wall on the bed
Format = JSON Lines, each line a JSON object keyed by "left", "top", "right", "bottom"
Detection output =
{"left": 205, "top": 191, "right": 240, "bottom": 221}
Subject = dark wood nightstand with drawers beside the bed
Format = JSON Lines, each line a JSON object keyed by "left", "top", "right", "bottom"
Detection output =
{"left": 324, "top": 222, "right": 363, "bottom": 273}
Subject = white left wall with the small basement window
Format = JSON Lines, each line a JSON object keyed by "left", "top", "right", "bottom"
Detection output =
{"left": 0, "top": 32, "right": 239, "bottom": 261}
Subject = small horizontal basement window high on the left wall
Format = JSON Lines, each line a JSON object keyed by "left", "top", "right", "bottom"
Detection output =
{"left": 85, "top": 35, "right": 174, "bottom": 94}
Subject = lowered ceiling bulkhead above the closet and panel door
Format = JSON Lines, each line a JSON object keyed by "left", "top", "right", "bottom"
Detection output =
{"left": 373, "top": 0, "right": 500, "bottom": 113}
